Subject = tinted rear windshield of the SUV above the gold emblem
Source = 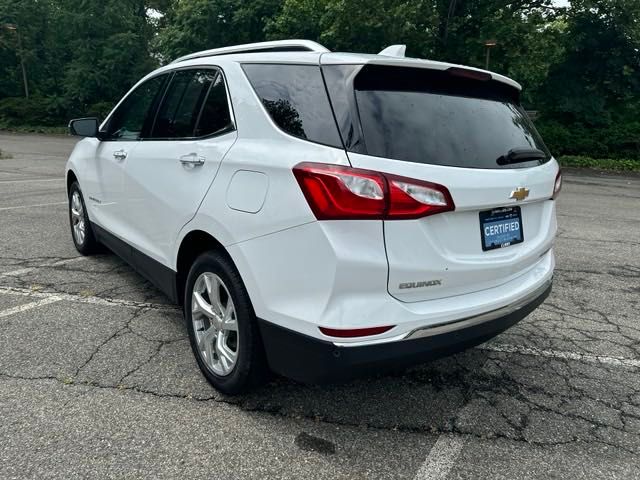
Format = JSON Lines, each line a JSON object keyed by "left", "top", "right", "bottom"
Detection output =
{"left": 330, "top": 65, "right": 550, "bottom": 168}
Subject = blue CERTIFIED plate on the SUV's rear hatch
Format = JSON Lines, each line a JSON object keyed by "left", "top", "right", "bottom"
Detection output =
{"left": 480, "top": 207, "right": 524, "bottom": 252}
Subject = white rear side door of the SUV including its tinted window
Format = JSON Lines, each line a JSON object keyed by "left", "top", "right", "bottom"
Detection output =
{"left": 124, "top": 68, "right": 236, "bottom": 265}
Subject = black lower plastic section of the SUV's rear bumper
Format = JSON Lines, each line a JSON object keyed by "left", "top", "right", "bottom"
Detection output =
{"left": 259, "top": 282, "right": 551, "bottom": 383}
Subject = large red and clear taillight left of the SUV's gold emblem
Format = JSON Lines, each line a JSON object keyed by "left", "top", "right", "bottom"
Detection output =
{"left": 293, "top": 163, "right": 455, "bottom": 220}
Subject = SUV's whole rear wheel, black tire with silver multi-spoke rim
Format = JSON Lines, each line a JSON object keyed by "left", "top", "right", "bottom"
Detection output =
{"left": 184, "top": 252, "right": 268, "bottom": 395}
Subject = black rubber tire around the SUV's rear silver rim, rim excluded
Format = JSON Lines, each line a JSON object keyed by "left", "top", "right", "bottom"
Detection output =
{"left": 184, "top": 251, "right": 268, "bottom": 395}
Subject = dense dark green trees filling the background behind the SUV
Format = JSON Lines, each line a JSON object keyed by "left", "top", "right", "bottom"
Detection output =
{"left": 0, "top": 0, "right": 640, "bottom": 158}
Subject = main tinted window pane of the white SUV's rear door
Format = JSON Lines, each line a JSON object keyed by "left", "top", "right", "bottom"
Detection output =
{"left": 152, "top": 70, "right": 217, "bottom": 138}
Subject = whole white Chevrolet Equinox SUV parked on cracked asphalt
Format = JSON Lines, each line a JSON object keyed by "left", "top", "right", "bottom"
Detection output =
{"left": 66, "top": 40, "right": 561, "bottom": 393}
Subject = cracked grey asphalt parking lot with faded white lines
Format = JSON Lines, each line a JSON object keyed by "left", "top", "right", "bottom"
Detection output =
{"left": 0, "top": 133, "right": 640, "bottom": 479}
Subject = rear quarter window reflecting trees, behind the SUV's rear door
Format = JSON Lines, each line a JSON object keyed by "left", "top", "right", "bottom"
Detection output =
{"left": 243, "top": 64, "right": 342, "bottom": 148}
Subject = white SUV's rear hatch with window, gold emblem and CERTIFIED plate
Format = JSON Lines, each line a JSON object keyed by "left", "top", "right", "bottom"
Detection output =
{"left": 323, "top": 60, "right": 558, "bottom": 302}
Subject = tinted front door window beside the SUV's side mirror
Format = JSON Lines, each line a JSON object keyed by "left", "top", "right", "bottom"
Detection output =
{"left": 107, "top": 75, "right": 167, "bottom": 140}
